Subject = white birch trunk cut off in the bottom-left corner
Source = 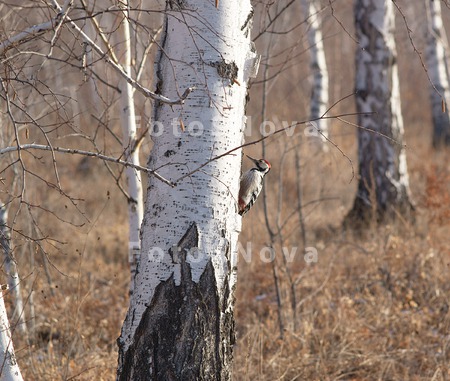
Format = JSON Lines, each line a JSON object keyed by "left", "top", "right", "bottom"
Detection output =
{"left": 0, "top": 286, "right": 23, "bottom": 381}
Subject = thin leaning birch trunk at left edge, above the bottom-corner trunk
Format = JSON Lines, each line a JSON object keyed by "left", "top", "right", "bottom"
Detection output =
{"left": 0, "top": 201, "right": 27, "bottom": 334}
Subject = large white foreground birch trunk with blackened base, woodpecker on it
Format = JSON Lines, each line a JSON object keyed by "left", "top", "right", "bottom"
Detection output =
{"left": 117, "top": 0, "right": 257, "bottom": 380}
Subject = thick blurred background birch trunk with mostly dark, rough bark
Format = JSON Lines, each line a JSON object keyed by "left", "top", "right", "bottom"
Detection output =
{"left": 348, "top": 0, "right": 413, "bottom": 223}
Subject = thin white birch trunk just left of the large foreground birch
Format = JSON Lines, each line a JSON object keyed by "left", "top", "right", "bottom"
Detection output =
{"left": 119, "top": 2, "right": 144, "bottom": 293}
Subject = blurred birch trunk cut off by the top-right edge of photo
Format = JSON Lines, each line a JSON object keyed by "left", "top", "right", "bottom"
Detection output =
{"left": 425, "top": 0, "right": 450, "bottom": 147}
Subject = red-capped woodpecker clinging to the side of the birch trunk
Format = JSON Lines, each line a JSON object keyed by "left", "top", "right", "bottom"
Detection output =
{"left": 238, "top": 155, "right": 271, "bottom": 216}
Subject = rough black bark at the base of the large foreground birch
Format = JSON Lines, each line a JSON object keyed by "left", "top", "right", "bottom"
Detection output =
{"left": 117, "top": 223, "right": 234, "bottom": 381}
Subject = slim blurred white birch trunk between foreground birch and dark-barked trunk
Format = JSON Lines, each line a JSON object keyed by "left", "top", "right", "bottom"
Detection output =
{"left": 302, "top": 0, "right": 329, "bottom": 142}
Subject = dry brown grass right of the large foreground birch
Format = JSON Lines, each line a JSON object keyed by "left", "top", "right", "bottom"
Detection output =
{"left": 235, "top": 144, "right": 450, "bottom": 380}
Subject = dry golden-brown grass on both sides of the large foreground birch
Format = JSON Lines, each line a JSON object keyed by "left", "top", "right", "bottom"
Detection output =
{"left": 5, "top": 134, "right": 450, "bottom": 380}
